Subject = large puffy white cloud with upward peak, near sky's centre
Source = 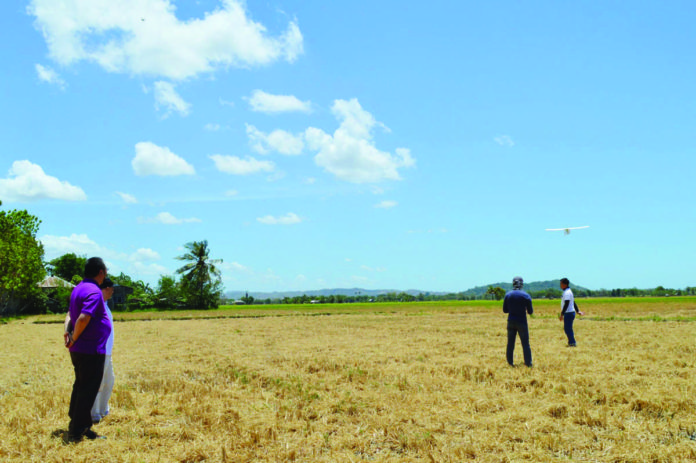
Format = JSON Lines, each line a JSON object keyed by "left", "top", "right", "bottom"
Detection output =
{"left": 305, "top": 99, "right": 415, "bottom": 183}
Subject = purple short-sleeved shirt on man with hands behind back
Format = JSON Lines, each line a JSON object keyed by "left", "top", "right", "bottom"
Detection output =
{"left": 70, "top": 278, "right": 111, "bottom": 354}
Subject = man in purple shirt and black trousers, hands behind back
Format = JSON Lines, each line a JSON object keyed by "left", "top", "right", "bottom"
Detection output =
{"left": 64, "top": 257, "right": 112, "bottom": 442}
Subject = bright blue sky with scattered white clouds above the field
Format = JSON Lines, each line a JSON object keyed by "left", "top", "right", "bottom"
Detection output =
{"left": 0, "top": 0, "right": 696, "bottom": 291}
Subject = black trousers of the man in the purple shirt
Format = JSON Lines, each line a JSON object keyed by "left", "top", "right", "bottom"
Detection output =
{"left": 68, "top": 352, "right": 106, "bottom": 438}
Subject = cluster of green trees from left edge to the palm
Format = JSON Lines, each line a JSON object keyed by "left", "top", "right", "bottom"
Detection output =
{"left": 0, "top": 201, "right": 223, "bottom": 317}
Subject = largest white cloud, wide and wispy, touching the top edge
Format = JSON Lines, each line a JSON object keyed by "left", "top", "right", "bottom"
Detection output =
{"left": 27, "top": 0, "right": 303, "bottom": 80}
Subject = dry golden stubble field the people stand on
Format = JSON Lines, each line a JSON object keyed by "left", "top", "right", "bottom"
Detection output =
{"left": 0, "top": 298, "right": 696, "bottom": 463}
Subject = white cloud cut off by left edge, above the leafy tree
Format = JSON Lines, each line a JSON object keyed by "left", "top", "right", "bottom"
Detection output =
{"left": 0, "top": 160, "right": 87, "bottom": 202}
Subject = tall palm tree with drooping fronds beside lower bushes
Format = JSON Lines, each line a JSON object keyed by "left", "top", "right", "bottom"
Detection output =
{"left": 176, "top": 240, "right": 222, "bottom": 310}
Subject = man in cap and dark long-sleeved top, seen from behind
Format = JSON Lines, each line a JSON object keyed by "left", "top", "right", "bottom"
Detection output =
{"left": 503, "top": 277, "right": 534, "bottom": 368}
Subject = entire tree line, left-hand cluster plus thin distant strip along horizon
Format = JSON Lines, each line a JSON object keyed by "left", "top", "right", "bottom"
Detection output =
{"left": 0, "top": 201, "right": 696, "bottom": 317}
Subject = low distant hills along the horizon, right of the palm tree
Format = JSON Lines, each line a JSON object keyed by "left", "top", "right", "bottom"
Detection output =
{"left": 225, "top": 280, "right": 586, "bottom": 300}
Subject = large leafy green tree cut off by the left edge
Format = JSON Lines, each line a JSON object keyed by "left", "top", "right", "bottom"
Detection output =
{"left": 0, "top": 202, "right": 46, "bottom": 315}
